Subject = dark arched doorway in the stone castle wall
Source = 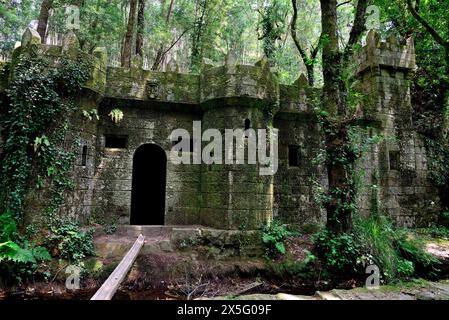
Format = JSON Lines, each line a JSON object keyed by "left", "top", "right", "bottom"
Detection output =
{"left": 131, "top": 144, "right": 167, "bottom": 225}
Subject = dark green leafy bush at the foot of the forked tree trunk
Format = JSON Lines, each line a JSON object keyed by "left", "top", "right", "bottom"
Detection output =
{"left": 314, "top": 230, "right": 363, "bottom": 274}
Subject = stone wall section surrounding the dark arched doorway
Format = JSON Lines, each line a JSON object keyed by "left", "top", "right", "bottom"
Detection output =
{"left": 92, "top": 100, "right": 201, "bottom": 224}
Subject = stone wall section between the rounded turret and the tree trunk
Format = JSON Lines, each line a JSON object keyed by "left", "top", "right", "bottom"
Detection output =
{"left": 273, "top": 80, "right": 327, "bottom": 224}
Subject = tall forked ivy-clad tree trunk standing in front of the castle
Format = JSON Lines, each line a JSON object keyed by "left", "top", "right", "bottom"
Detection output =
{"left": 320, "top": 0, "right": 369, "bottom": 233}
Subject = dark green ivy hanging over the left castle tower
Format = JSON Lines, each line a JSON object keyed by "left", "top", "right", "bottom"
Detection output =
{"left": 0, "top": 58, "right": 88, "bottom": 220}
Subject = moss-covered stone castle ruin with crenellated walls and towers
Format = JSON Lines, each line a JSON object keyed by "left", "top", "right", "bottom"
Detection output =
{"left": 0, "top": 29, "right": 439, "bottom": 229}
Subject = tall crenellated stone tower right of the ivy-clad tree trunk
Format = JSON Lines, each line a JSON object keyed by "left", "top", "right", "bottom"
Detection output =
{"left": 357, "top": 31, "right": 441, "bottom": 226}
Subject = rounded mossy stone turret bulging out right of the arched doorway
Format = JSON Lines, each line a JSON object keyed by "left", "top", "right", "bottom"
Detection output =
{"left": 200, "top": 53, "right": 279, "bottom": 229}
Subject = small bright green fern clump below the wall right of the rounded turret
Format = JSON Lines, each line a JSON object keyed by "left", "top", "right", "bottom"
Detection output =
{"left": 262, "top": 221, "right": 293, "bottom": 257}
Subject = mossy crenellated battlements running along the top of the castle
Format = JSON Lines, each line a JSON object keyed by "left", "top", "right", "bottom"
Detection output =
{"left": 8, "top": 28, "right": 415, "bottom": 112}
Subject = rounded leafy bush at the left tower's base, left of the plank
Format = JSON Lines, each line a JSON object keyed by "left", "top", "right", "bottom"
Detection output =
{"left": 47, "top": 221, "right": 95, "bottom": 262}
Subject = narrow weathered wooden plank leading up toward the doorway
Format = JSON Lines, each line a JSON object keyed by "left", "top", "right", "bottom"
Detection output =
{"left": 90, "top": 235, "right": 145, "bottom": 300}
